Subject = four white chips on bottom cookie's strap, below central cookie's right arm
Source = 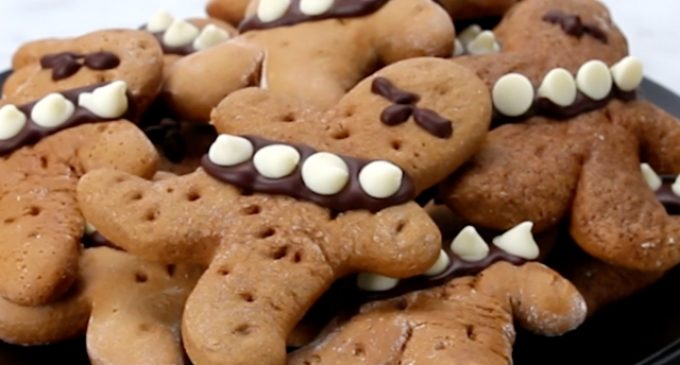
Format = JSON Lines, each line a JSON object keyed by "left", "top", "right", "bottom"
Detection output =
{"left": 357, "top": 221, "right": 539, "bottom": 291}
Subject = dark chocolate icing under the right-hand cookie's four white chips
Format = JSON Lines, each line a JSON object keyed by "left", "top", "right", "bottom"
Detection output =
{"left": 494, "top": 85, "right": 637, "bottom": 125}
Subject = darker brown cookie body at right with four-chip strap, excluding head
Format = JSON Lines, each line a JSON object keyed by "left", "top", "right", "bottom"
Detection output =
{"left": 443, "top": 53, "right": 680, "bottom": 271}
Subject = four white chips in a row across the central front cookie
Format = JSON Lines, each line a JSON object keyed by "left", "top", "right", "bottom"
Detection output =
{"left": 208, "top": 134, "right": 404, "bottom": 199}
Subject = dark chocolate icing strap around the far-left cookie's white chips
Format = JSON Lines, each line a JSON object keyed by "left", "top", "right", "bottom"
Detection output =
{"left": 0, "top": 83, "right": 133, "bottom": 156}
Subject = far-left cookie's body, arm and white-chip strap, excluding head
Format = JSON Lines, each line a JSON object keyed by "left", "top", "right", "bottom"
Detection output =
{"left": 0, "top": 81, "right": 157, "bottom": 305}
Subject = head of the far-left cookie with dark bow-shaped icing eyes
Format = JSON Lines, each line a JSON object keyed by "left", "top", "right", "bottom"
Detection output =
{"left": 3, "top": 30, "right": 163, "bottom": 112}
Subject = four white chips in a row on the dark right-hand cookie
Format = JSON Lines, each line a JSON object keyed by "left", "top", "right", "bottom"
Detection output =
{"left": 492, "top": 56, "right": 643, "bottom": 117}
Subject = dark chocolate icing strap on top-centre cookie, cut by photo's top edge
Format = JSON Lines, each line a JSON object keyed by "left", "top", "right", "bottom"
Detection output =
{"left": 238, "top": 0, "right": 389, "bottom": 32}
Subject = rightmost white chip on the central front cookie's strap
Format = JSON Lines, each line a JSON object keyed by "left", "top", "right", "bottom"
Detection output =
{"left": 359, "top": 161, "right": 404, "bottom": 199}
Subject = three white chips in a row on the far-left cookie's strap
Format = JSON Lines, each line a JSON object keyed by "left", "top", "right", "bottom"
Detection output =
{"left": 0, "top": 81, "right": 128, "bottom": 140}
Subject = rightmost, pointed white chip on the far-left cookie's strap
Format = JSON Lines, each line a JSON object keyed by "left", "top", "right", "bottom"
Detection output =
{"left": 78, "top": 81, "right": 128, "bottom": 119}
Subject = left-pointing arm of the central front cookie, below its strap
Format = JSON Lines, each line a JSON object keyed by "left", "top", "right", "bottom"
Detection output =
{"left": 78, "top": 170, "right": 226, "bottom": 264}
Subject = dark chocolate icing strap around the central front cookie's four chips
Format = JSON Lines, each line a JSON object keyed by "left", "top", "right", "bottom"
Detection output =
{"left": 201, "top": 136, "right": 415, "bottom": 212}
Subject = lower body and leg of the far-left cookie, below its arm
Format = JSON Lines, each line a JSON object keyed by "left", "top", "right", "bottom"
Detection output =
{"left": 0, "top": 177, "right": 84, "bottom": 305}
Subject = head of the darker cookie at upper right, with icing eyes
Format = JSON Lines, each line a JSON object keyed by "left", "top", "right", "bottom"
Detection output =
{"left": 455, "top": 0, "right": 628, "bottom": 87}
